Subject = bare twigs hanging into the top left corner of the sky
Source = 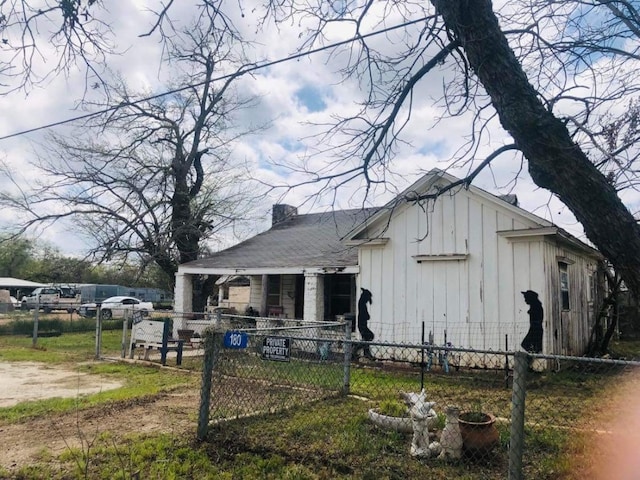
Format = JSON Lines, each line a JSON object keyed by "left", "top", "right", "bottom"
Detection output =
{"left": 0, "top": 0, "right": 240, "bottom": 95}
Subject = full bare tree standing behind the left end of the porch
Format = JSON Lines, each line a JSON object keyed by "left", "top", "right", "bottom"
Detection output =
{"left": 0, "top": 5, "right": 262, "bottom": 305}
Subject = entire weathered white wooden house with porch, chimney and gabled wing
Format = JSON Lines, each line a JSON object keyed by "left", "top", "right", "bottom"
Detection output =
{"left": 175, "top": 170, "right": 602, "bottom": 355}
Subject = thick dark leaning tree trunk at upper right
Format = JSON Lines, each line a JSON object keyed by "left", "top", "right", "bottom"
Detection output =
{"left": 431, "top": 0, "right": 640, "bottom": 296}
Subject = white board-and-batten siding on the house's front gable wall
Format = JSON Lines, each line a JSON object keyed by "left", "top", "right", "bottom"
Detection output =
{"left": 358, "top": 190, "right": 546, "bottom": 356}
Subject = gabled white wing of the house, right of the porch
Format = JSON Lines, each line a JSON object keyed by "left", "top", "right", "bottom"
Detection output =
{"left": 346, "top": 170, "right": 602, "bottom": 355}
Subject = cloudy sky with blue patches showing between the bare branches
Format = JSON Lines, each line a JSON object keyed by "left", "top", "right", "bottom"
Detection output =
{"left": 0, "top": 0, "right": 612, "bottom": 254}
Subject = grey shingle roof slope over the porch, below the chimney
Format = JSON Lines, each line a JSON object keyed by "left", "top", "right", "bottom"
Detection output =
{"left": 183, "top": 209, "right": 377, "bottom": 269}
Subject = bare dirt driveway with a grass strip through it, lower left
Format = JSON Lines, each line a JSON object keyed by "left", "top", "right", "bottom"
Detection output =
{"left": 0, "top": 362, "right": 200, "bottom": 470}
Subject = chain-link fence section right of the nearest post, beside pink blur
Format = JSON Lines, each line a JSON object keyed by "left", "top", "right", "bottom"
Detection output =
{"left": 509, "top": 353, "right": 640, "bottom": 479}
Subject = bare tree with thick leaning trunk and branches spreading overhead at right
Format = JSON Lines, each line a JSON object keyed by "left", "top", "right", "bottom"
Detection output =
{"left": 258, "top": 0, "right": 640, "bottom": 295}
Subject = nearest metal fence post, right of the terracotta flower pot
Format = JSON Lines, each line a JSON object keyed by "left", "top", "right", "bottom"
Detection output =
{"left": 508, "top": 352, "right": 529, "bottom": 480}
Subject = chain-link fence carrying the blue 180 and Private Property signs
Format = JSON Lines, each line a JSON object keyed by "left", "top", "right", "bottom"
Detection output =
{"left": 192, "top": 316, "right": 640, "bottom": 479}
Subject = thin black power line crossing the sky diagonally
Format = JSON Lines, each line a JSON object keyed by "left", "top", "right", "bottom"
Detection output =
{"left": 0, "top": 17, "right": 428, "bottom": 141}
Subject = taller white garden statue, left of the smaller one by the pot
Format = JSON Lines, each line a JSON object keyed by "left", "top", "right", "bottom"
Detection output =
{"left": 400, "top": 389, "right": 440, "bottom": 458}
